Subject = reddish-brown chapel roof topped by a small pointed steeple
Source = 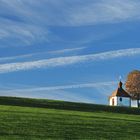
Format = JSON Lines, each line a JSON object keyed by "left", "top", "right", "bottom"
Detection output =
{"left": 109, "top": 81, "right": 131, "bottom": 98}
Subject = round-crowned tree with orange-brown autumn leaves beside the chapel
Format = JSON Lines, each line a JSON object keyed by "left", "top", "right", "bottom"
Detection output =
{"left": 125, "top": 70, "right": 140, "bottom": 107}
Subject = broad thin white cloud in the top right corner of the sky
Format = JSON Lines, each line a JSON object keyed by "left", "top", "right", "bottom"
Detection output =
{"left": 69, "top": 0, "right": 140, "bottom": 25}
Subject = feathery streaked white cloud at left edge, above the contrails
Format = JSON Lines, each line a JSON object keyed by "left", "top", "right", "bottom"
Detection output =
{"left": 0, "top": 21, "right": 48, "bottom": 46}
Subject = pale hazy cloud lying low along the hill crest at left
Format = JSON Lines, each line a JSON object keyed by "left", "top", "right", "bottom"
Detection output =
{"left": 0, "top": 90, "right": 95, "bottom": 102}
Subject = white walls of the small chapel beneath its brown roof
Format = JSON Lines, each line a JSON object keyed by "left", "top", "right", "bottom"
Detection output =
{"left": 109, "top": 96, "right": 131, "bottom": 107}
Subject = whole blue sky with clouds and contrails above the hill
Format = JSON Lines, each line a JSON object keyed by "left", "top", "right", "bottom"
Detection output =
{"left": 0, "top": 0, "right": 140, "bottom": 104}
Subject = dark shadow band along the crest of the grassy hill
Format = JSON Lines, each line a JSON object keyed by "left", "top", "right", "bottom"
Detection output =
{"left": 0, "top": 97, "right": 140, "bottom": 115}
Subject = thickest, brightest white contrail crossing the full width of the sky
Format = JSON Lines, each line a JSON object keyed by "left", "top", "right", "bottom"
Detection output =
{"left": 0, "top": 48, "right": 140, "bottom": 73}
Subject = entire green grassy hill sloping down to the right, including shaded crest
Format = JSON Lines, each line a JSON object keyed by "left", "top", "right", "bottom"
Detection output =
{"left": 0, "top": 97, "right": 140, "bottom": 140}
